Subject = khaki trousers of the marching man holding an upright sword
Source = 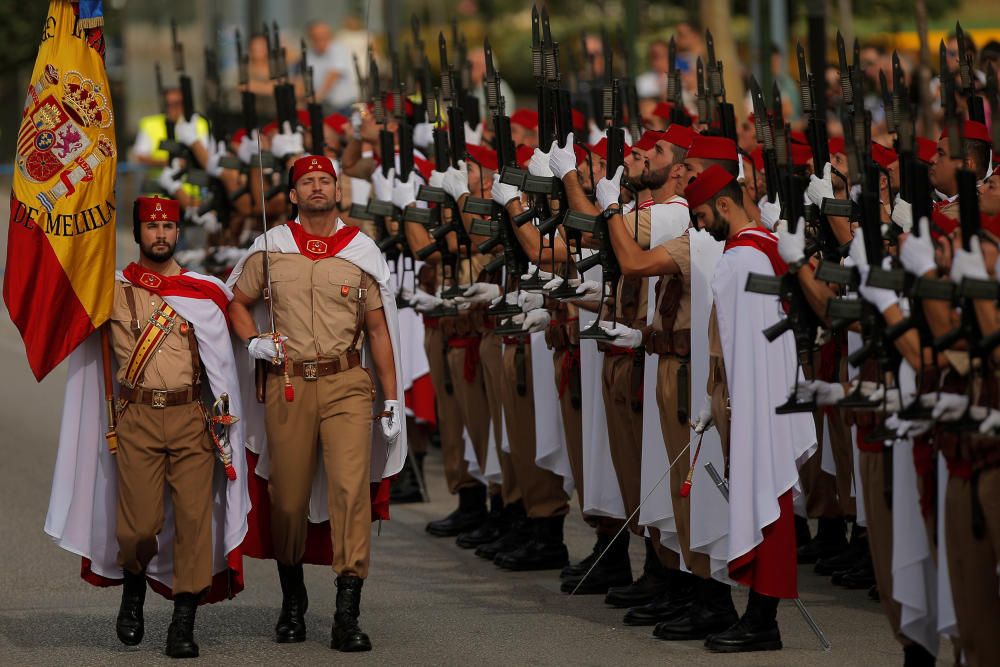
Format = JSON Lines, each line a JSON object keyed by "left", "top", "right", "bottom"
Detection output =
{"left": 267, "top": 366, "right": 374, "bottom": 578}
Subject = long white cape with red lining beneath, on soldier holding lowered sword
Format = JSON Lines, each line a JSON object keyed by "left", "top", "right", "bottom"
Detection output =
{"left": 712, "top": 244, "right": 816, "bottom": 562}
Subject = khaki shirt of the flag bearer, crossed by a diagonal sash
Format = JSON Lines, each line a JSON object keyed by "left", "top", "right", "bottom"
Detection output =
{"left": 111, "top": 280, "right": 194, "bottom": 390}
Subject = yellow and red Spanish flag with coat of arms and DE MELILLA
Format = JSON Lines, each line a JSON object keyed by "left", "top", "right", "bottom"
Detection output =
{"left": 3, "top": 0, "right": 117, "bottom": 381}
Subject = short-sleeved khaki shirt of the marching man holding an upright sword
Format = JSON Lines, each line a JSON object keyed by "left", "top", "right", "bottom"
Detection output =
{"left": 236, "top": 252, "right": 382, "bottom": 361}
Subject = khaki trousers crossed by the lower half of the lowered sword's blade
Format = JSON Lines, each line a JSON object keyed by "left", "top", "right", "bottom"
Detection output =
{"left": 601, "top": 354, "right": 642, "bottom": 534}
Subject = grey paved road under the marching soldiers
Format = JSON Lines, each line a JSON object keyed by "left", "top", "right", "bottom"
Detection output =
{"left": 0, "top": 239, "right": 916, "bottom": 667}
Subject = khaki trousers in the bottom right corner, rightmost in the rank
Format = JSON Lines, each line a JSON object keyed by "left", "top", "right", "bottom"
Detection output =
{"left": 944, "top": 468, "right": 1000, "bottom": 667}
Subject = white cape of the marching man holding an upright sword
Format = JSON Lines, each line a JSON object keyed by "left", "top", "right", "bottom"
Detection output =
{"left": 227, "top": 219, "right": 406, "bottom": 523}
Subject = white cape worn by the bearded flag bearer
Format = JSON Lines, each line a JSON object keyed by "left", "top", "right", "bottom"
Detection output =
{"left": 45, "top": 272, "right": 250, "bottom": 588}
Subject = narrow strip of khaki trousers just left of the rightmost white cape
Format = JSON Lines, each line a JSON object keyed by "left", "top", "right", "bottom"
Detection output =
{"left": 858, "top": 448, "right": 913, "bottom": 646}
